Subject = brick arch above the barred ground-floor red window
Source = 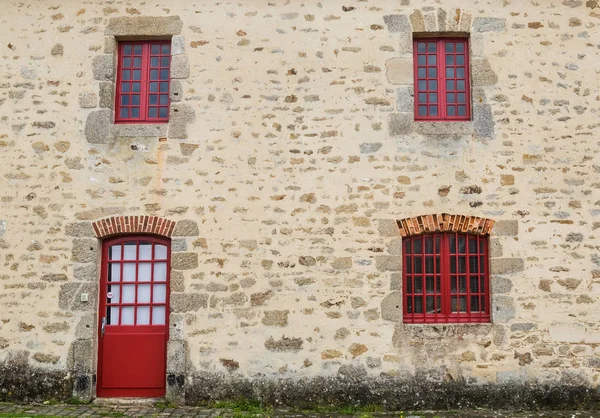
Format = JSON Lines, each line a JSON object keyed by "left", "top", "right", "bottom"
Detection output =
{"left": 396, "top": 213, "right": 495, "bottom": 237}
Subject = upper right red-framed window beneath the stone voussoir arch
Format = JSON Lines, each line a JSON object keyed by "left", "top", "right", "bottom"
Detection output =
{"left": 413, "top": 38, "right": 471, "bottom": 121}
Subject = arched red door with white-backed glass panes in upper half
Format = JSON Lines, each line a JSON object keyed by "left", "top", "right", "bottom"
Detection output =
{"left": 97, "top": 236, "right": 171, "bottom": 397}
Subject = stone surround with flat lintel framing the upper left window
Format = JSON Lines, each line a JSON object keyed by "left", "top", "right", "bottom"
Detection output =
{"left": 85, "top": 16, "right": 195, "bottom": 144}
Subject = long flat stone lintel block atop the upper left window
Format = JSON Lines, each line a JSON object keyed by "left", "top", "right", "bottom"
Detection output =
{"left": 104, "top": 16, "right": 183, "bottom": 37}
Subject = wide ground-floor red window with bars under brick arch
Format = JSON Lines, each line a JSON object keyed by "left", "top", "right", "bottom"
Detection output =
{"left": 402, "top": 232, "right": 490, "bottom": 323}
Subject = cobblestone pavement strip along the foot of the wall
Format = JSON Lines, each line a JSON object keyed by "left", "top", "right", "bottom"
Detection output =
{"left": 0, "top": 403, "right": 600, "bottom": 418}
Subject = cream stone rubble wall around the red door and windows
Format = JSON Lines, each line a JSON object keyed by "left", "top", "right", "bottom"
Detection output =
{"left": 0, "top": 0, "right": 600, "bottom": 407}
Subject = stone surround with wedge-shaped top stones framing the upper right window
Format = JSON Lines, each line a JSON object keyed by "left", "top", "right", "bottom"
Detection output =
{"left": 383, "top": 7, "right": 506, "bottom": 138}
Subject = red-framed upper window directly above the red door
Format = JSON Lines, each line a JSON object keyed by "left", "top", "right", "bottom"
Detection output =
{"left": 115, "top": 41, "right": 171, "bottom": 123}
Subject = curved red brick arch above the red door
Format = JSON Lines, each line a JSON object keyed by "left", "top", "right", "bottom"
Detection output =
{"left": 92, "top": 215, "right": 175, "bottom": 238}
